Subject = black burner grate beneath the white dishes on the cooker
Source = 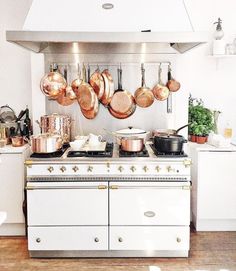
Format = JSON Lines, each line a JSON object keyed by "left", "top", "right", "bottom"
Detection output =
{"left": 67, "top": 143, "right": 113, "bottom": 158}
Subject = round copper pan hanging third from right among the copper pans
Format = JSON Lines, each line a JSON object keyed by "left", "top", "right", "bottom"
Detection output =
{"left": 134, "top": 63, "right": 154, "bottom": 107}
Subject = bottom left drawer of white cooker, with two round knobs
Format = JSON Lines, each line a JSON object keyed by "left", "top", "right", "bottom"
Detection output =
{"left": 28, "top": 226, "right": 108, "bottom": 250}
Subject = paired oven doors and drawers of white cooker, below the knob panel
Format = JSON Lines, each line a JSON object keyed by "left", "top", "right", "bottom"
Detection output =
{"left": 27, "top": 181, "right": 190, "bottom": 257}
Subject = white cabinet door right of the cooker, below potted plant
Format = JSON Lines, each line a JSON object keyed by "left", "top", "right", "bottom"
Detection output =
{"left": 197, "top": 152, "right": 236, "bottom": 219}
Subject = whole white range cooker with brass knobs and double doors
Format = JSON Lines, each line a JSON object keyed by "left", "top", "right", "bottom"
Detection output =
{"left": 25, "top": 144, "right": 191, "bottom": 257}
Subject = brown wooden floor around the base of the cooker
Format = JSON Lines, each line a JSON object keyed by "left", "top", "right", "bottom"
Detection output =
{"left": 0, "top": 232, "right": 236, "bottom": 271}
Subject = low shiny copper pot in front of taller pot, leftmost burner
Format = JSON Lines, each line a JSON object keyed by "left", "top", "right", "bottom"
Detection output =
{"left": 30, "top": 134, "right": 63, "bottom": 153}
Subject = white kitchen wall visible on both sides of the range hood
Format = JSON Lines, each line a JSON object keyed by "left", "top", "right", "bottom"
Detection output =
{"left": 0, "top": 0, "right": 236, "bottom": 138}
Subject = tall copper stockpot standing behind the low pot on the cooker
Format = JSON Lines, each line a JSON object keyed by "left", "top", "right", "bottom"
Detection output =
{"left": 40, "top": 113, "right": 71, "bottom": 143}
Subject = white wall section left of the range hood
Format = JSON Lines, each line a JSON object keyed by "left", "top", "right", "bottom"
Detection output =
{"left": 0, "top": 0, "right": 32, "bottom": 114}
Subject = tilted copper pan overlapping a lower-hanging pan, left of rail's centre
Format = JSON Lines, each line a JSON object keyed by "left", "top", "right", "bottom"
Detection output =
{"left": 77, "top": 65, "right": 97, "bottom": 111}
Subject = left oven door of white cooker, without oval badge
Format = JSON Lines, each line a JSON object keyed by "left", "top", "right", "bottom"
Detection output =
{"left": 26, "top": 182, "right": 108, "bottom": 226}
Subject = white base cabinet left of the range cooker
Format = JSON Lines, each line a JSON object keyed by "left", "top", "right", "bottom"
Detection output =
{"left": 0, "top": 146, "right": 29, "bottom": 235}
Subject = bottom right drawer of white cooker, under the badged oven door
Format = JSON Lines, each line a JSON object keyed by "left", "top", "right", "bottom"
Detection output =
{"left": 110, "top": 226, "right": 190, "bottom": 250}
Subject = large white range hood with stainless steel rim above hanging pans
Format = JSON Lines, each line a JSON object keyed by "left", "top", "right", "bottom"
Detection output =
{"left": 6, "top": 0, "right": 208, "bottom": 54}
